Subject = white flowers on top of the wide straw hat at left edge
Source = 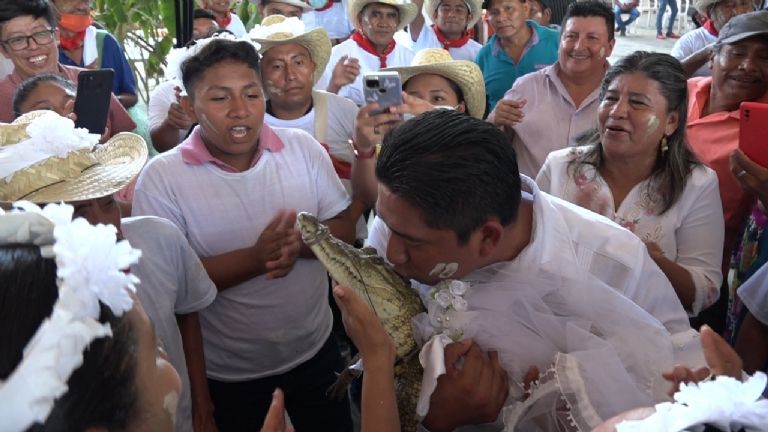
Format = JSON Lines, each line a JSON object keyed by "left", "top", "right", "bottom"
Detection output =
{"left": 0, "top": 111, "right": 100, "bottom": 180}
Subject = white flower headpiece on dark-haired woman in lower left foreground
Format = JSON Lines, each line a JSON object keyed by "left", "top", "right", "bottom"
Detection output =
{"left": 0, "top": 201, "right": 141, "bottom": 432}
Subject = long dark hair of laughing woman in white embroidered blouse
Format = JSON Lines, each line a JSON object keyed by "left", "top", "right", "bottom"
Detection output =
{"left": 568, "top": 51, "right": 699, "bottom": 214}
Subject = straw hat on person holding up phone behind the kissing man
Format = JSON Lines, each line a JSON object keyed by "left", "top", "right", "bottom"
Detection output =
{"left": 383, "top": 48, "right": 485, "bottom": 119}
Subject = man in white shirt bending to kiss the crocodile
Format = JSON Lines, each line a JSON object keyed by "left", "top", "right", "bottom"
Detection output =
{"left": 371, "top": 110, "right": 703, "bottom": 431}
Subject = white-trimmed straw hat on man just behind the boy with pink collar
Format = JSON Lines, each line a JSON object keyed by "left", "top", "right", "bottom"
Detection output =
{"left": 248, "top": 15, "right": 331, "bottom": 84}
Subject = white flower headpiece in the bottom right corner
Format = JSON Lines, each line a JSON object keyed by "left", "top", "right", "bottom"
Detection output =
{"left": 616, "top": 372, "right": 768, "bottom": 432}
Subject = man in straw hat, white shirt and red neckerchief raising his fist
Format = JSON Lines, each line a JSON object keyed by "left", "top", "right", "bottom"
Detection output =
{"left": 315, "top": 0, "right": 418, "bottom": 106}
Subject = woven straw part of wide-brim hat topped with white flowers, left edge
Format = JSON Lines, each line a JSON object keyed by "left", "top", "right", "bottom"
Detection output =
{"left": 0, "top": 111, "right": 148, "bottom": 203}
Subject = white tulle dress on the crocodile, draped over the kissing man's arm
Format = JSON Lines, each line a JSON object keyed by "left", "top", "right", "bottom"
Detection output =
{"left": 414, "top": 263, "right": 690, "bottom": 431}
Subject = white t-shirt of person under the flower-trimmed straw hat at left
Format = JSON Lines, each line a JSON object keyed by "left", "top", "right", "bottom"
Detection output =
{"left": 121, "top": 216, "right": 216, "bottom": 432}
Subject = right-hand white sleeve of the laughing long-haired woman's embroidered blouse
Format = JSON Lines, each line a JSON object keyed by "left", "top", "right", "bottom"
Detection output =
{"left": 671, "top": 167, "right": 725, "bottom": 316}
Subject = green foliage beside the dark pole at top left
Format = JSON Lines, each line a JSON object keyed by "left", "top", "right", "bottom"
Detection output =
{"left": 92, "top": 0, "right": 176, "bottom": 101}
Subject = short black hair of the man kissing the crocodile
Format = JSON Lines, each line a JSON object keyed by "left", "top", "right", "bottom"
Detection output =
{"left": 376, "top": 109, "right": 520, "bottom": 244}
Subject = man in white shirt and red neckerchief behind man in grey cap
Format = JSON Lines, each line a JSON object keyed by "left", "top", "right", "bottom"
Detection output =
{"left": 670, "top": 0, "right": 754, "bottom": 77}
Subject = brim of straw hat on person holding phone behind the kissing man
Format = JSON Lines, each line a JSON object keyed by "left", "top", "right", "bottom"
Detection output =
{"left": 383, "top": 60, "right": 485, "bottom": 120}
